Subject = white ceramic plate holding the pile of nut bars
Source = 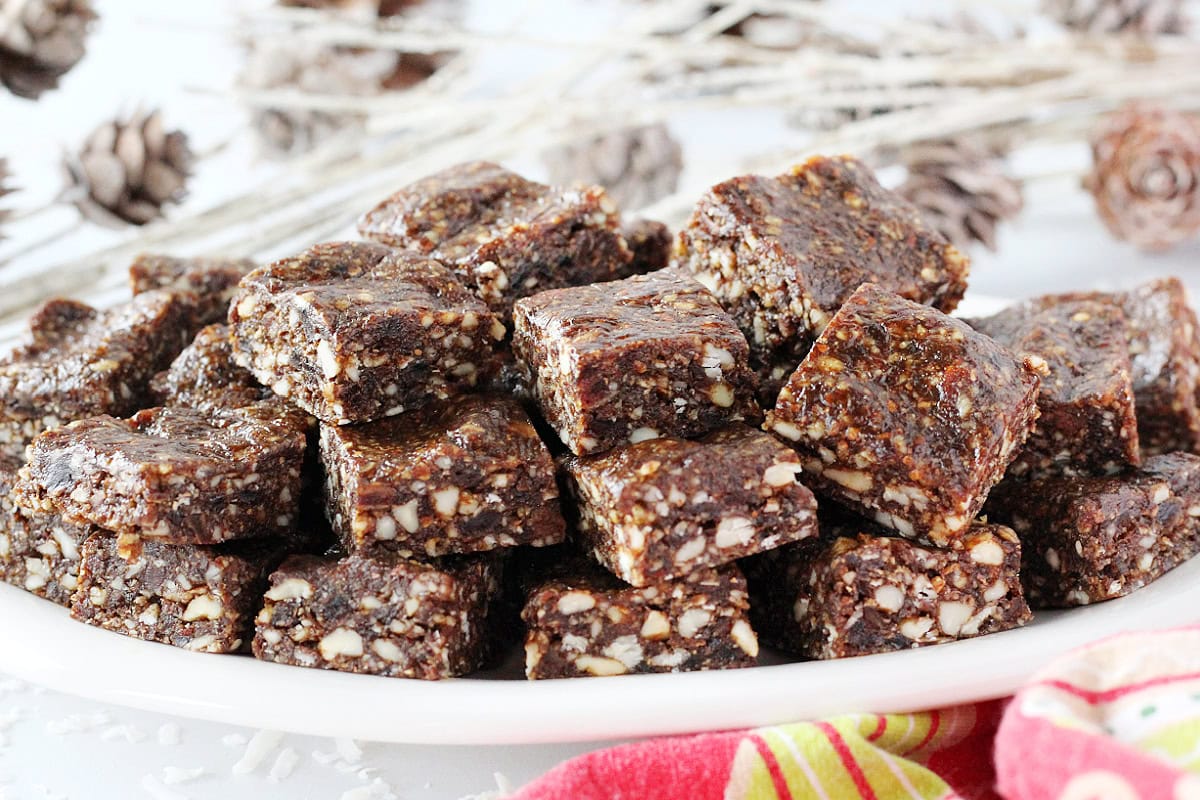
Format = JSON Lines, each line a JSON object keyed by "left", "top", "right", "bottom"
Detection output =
{"left": 7, "top": 297, "right": 1180, "bottom": 745}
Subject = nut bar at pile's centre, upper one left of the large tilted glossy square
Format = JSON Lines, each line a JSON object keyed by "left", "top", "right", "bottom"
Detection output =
{"left": 512, "top": 270, "right": 758, "bottom": 456}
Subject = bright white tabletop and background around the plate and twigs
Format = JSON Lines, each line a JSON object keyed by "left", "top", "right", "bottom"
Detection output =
{"left": 0, "top": 0, "right": 1200, "bottom": 800}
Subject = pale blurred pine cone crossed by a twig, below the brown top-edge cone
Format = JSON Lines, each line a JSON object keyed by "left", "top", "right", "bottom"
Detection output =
{"left": 241, "top": 44, "right": 401, "bottom": 156}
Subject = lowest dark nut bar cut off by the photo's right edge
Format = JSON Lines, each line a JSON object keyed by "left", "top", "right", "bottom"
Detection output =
{"left": 986, "top": 453, "right": 1200, "bottom": 608}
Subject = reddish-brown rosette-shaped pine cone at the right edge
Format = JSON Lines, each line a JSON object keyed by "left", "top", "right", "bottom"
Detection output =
{"left": 1084, "top": 104, "right": 1200, "bottom": 251}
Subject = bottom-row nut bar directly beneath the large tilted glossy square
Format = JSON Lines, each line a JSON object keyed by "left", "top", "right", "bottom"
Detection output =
{"left": 742, "top": 515, "right": 1032, "bottom": 658}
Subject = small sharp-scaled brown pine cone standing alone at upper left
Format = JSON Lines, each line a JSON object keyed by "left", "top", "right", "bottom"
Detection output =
{"left": 62, "top": 112, "right": 192, "bottom": 228}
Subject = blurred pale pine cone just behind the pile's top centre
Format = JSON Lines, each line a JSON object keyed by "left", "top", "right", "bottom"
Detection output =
{"left": 542, "top": 125, "right": 683, "bottom": 209}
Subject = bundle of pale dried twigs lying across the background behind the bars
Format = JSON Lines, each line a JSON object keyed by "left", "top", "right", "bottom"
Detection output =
{"left": 0, "top": 0, "right": 1200, "bottom": 332}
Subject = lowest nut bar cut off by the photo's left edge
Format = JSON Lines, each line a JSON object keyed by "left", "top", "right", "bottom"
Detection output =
{"left": 0, "top": 459, "right": 96, "bottom": 606}
